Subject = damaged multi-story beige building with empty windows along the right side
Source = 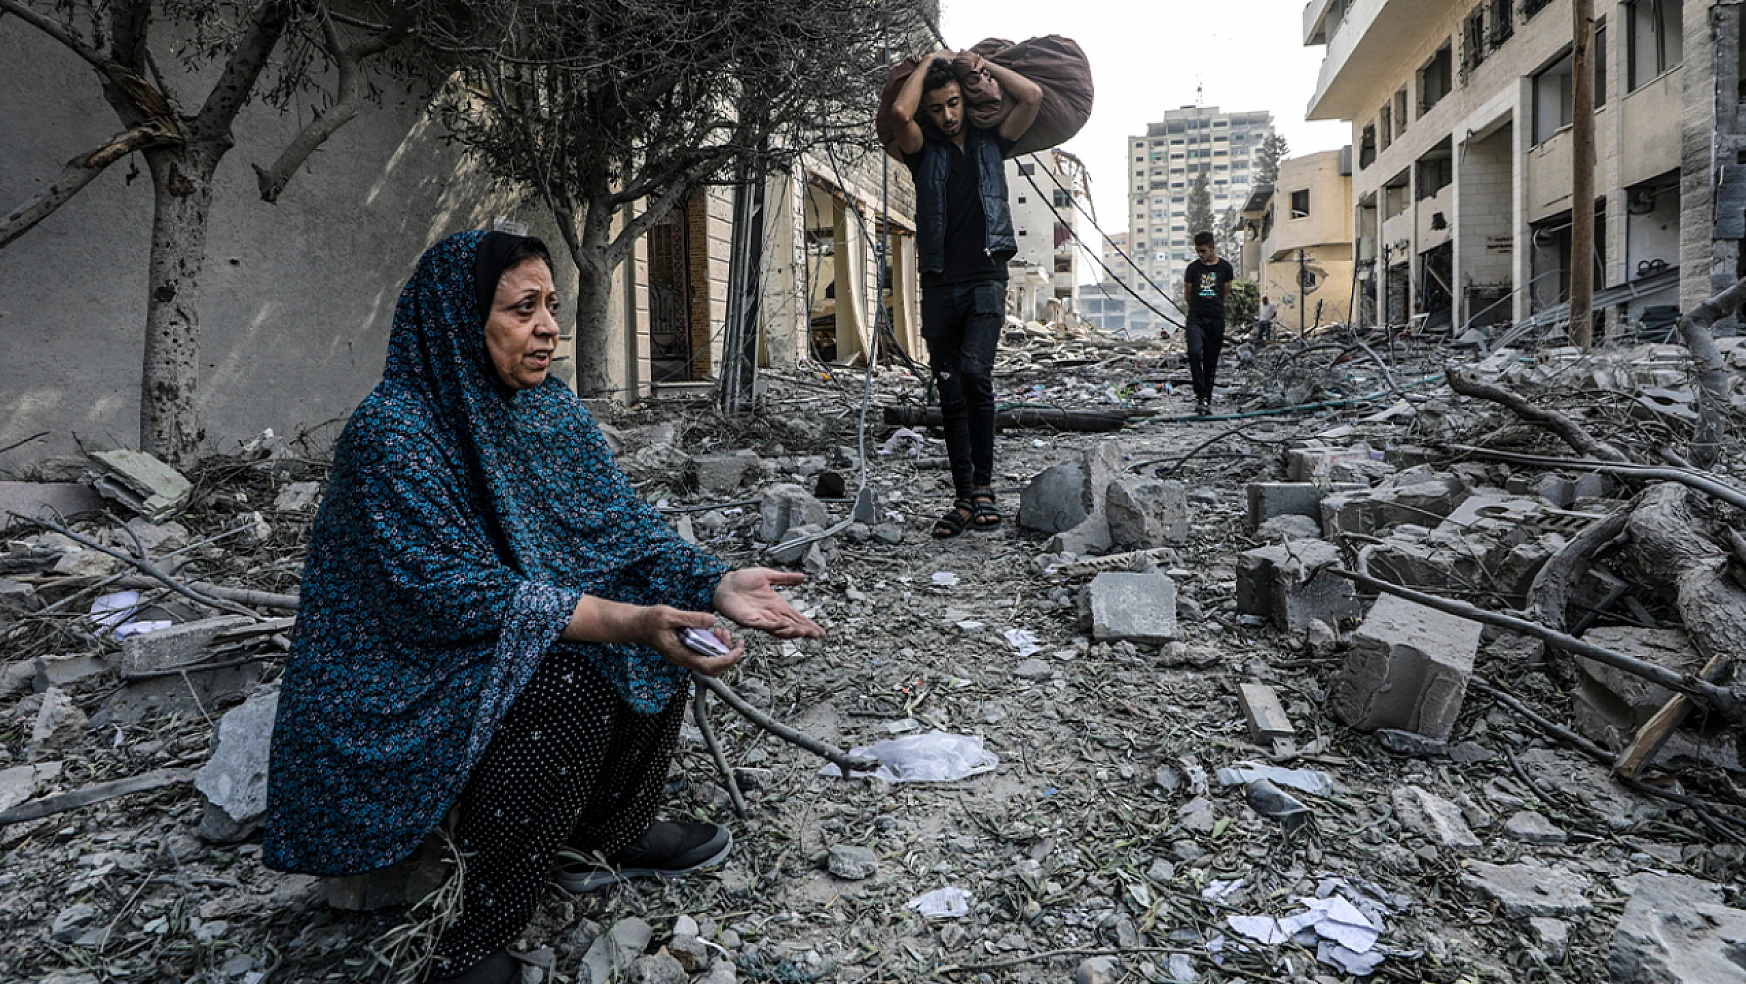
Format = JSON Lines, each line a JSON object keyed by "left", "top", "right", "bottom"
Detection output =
{"left": 1303, "top": 0, "right": 1746, "bottom": 331}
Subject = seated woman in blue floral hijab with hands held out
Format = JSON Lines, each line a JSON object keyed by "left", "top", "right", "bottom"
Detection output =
{"left": 264, "top": 232, "right": 824, "bottom": 982}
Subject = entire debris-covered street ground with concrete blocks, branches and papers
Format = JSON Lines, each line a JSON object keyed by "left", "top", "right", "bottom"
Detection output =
{"left": 0, "top": 323, "right": 1746, "bottom": 984}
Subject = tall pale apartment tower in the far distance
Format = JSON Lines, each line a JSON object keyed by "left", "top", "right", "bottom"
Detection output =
{"left": 1128, "top": 106, "right": 1273, "bottom": 295}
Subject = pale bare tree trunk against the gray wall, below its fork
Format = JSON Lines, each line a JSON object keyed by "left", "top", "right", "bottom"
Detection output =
{"left": 140, "top": 147, "right": 223, "bottom": 466}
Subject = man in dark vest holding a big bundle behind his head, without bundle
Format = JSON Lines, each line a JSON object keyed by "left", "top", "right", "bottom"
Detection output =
{"left": 887, "top": 51, "right": 1042, "bottom": 539}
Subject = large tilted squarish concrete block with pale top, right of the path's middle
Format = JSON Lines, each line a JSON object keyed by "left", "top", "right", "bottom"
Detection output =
{"left": 1329, "top": 595, "right": 1481, "bottom": 741}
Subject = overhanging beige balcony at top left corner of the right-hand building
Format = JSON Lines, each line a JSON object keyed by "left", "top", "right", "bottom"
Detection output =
{"left": 1304, "top": 0, "right": 1449, "bottom": 120}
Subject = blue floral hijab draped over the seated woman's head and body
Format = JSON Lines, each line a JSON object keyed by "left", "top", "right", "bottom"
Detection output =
{"left": 264, "top": 232, "right": 726, "bottom": 874}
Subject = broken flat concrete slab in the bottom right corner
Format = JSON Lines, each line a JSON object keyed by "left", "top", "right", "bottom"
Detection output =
{"left": 1608, "top": 872, "right": 1746, "bottom": 984}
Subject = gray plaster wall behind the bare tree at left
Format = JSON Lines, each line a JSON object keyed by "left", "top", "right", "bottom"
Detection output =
{"left": 0, "top": 17, "right": 574, "bottom": 473}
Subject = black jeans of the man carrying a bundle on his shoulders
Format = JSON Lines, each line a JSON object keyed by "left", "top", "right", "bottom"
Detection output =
{"left": 922, "top": 281, "right": 1006, "bottom": 499}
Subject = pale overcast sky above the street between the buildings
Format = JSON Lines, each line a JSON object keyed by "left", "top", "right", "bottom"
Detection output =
{"left": 941, "top": 0, "right": 1351, "bottom": 244}
